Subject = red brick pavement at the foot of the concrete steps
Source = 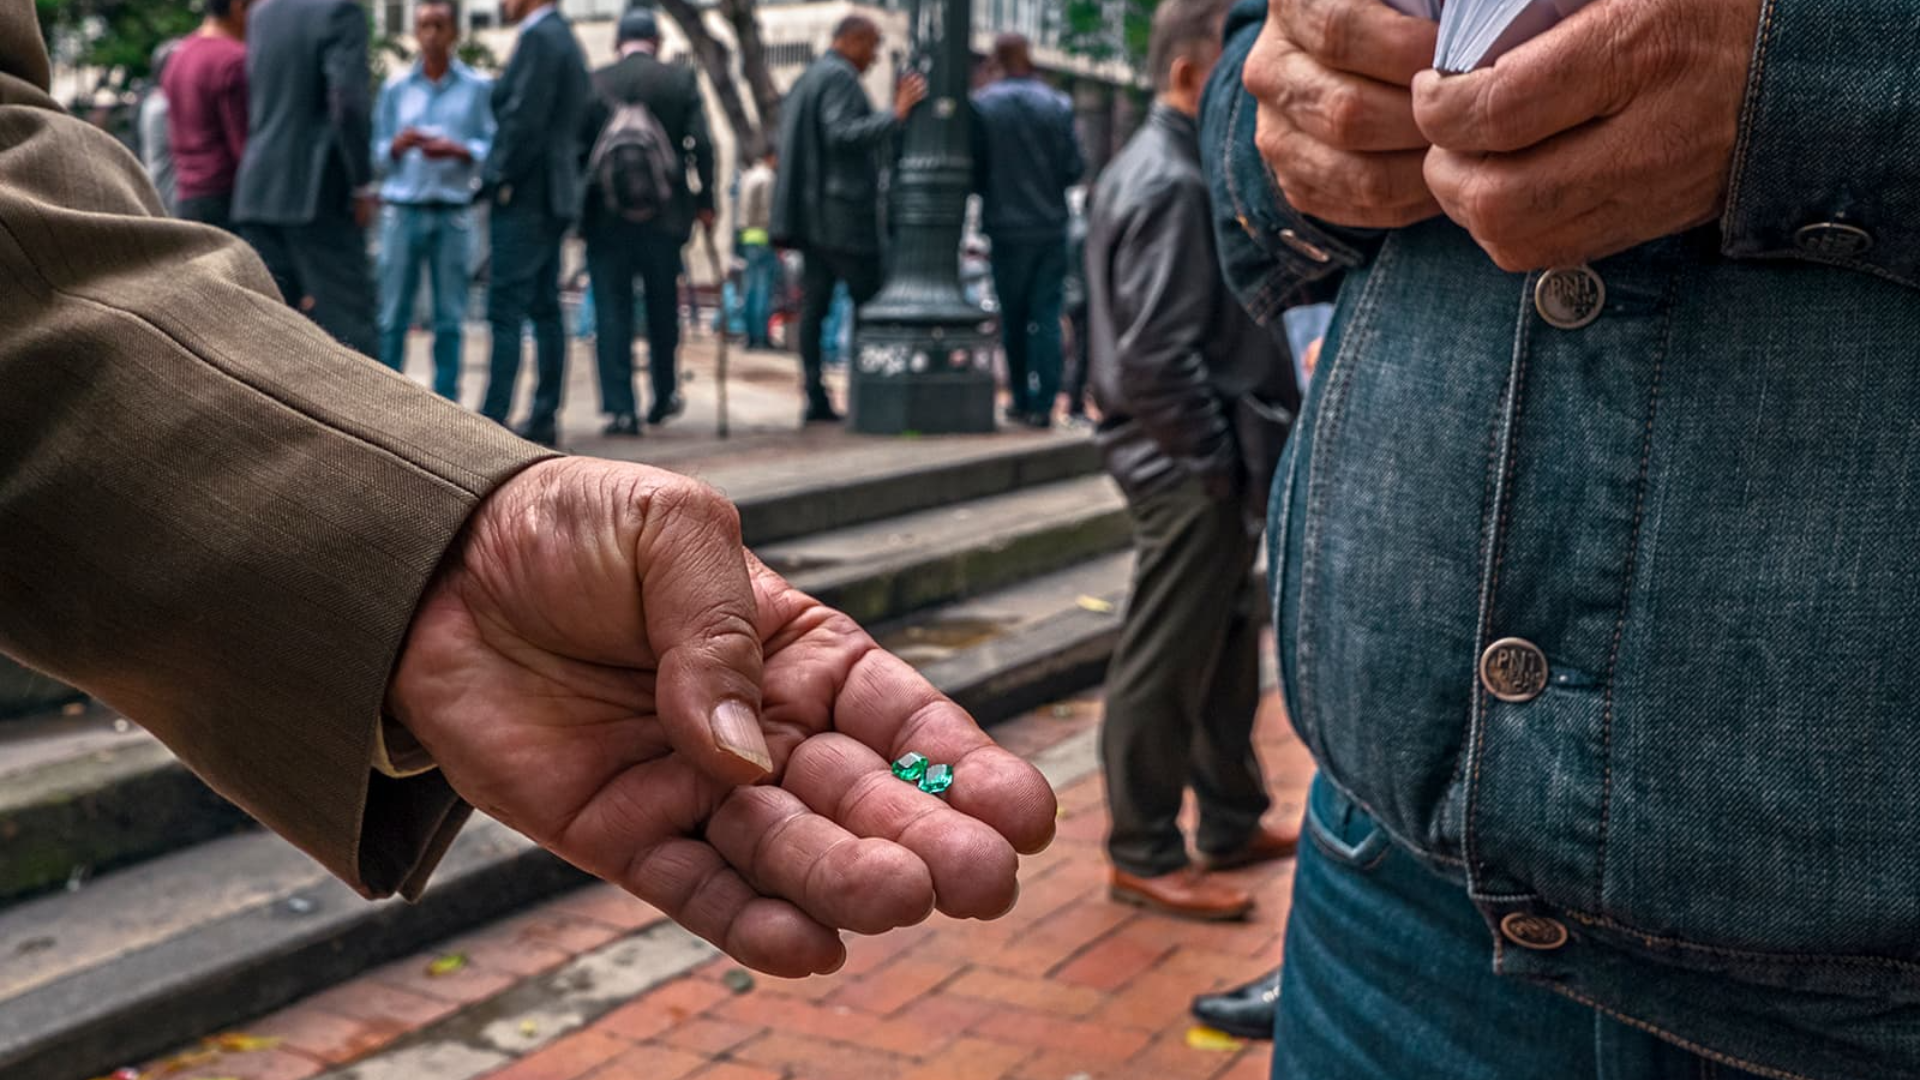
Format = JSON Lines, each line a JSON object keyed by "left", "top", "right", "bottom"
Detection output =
{"left": 127, "top": 696, "right": 1311, "bottom": 1080}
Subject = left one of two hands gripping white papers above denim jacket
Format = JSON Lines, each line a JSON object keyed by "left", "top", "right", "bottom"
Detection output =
{"left": 1242, "top": 0, "right": 1440, "bottom": 229}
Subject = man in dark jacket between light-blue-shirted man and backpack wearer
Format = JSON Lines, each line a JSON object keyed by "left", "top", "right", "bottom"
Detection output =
{"left": 480, "top": 0, "right": 593, "bottom": 446}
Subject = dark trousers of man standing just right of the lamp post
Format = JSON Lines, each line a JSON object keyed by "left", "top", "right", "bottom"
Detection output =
{"left": 993, "top": 236, "right": 1068, "bottom": 415}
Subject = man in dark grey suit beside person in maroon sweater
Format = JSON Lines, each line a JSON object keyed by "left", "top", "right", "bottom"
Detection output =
{"left": 232, "top": 0, "right": 380, "bottom": 356}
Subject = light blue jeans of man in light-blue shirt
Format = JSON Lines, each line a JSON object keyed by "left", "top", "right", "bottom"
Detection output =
{"left": 380, "top": 204, "right": 472, "bottom": 402}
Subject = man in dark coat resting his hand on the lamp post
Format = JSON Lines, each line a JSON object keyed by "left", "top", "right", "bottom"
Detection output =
{"left": 772, "top": 15, "right": 927, "bottom": 423}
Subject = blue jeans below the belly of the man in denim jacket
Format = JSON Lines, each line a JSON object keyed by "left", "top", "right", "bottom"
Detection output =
{"left": 1273, "top": 776, "right": 1757, "bottom": 1080}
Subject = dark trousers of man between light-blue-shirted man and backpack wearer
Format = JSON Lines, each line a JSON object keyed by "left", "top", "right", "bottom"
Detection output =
{"left": 480, "top": 206, "right": 566, "bottom": 434}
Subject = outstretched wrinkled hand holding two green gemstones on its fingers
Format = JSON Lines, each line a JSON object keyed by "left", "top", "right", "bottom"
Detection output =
{"left": 388, "top": 457, "right": 1054, "bottom": 976}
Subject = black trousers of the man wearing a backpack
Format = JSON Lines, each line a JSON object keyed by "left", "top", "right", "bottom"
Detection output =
{"left": 588, "top": 221, "right": 684, "bottom": 417}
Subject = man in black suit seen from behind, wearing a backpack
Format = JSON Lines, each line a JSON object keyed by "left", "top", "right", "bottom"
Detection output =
{"left": 580, "top": 8, "right": 714, "bottom": 434}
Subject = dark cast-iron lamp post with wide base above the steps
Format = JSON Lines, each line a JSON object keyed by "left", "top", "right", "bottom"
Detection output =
{"left": 849, "top": 0, "right": 995, "bottom": 434}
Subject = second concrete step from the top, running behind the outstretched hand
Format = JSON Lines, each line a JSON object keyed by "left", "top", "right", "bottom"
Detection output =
{"left": 0, "top": 461, "right": 1127, "bottom": 903}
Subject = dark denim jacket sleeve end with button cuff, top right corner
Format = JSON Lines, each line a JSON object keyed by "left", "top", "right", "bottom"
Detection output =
{"left": 1720, "top": 0, "right": 1920, "bottom": 286}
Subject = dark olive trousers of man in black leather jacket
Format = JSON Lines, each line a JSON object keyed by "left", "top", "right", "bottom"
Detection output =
{"left": 1100, "top": 479, "right": 1269, "bottom": 878}
